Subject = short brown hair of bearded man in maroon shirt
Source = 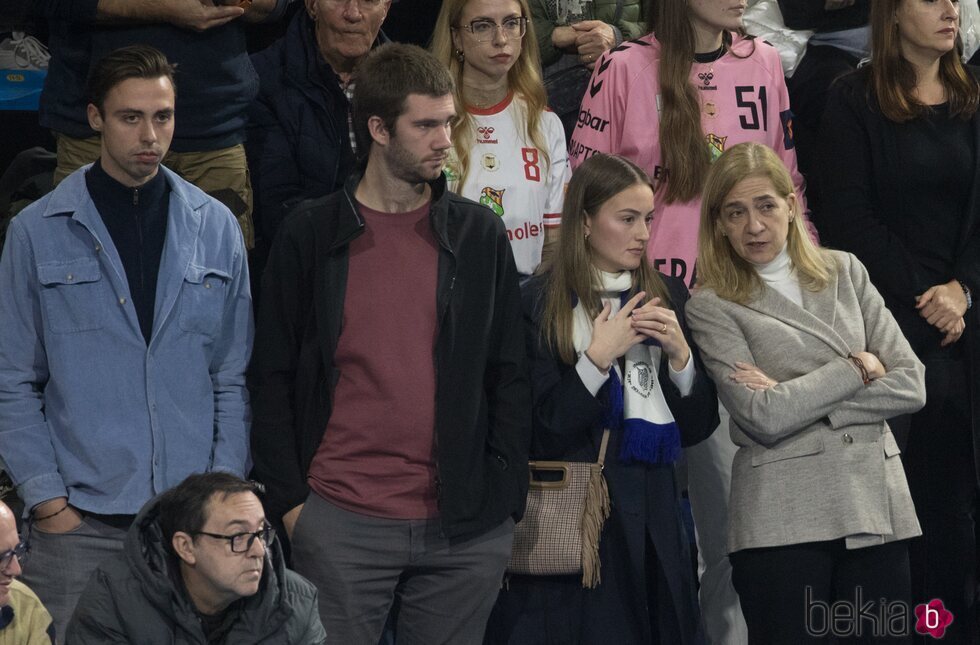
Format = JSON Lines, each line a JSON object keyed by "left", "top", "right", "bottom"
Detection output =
{"left": 351, "top": 43, "right": 453, "bottom": 159}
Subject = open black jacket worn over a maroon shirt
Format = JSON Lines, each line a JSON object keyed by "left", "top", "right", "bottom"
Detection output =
{"left": 249, "top": 173, "right": 531, "bottom": 541}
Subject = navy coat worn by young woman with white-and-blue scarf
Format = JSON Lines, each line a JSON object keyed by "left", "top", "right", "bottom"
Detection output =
{"left": 486, "top": 276, "right": 718, "bottom": 645}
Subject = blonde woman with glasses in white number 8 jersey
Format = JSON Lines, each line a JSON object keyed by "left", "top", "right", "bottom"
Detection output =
{"left": 432, "top": 0, "right": 569, "bottom": 275}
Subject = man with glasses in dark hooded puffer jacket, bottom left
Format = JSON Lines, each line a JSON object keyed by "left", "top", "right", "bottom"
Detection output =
{"left": 66, "top": 472, "right": 326, "bottom": 645}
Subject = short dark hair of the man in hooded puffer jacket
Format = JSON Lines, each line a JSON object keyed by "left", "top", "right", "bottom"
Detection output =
{"left": 157, "top": 472, "right": 261, "bottom": 550}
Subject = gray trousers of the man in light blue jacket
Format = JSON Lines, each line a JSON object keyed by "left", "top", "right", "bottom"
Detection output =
{"left": 21, "top": 516, "right": 126, "bottom": 642}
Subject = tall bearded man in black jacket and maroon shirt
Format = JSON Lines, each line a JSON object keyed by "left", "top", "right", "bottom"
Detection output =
{"left": 250, "top": 45, "right": 530, "bottom": 643}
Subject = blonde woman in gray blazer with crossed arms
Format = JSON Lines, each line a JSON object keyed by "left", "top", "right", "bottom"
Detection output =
{"left": 687, "top": 143, "right": 925, "bottom": 644}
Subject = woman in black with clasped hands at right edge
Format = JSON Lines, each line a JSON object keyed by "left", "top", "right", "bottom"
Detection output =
{"left": 817, "top": 0, "right": 980, "bottom": 643}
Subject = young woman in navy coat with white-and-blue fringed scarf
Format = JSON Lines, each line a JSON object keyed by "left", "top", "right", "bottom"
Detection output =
{"left": 487, "top": 154, "right": 718, "bottom": 645}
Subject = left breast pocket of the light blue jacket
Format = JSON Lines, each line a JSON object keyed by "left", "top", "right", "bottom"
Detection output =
{"left": 37, "top": 258, "right": 108, "bottom": 334}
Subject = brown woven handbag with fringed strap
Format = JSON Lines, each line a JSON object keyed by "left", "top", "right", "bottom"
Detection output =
{"left": 507, "top": 429, "right": 609, "bottom": 589}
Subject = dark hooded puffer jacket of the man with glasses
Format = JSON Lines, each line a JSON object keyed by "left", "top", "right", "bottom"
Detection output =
{"left": 65, "top": 499, "right": 326, "bottom": 645}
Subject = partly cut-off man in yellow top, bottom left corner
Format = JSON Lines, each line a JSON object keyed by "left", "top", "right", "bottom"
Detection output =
{"left": 0, "top": 502, "right": 54, "bottom": 645}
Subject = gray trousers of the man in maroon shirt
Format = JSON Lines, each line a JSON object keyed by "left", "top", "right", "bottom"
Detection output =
{"left": 292, "top": 493, "right": 514, "bottom": 645}
